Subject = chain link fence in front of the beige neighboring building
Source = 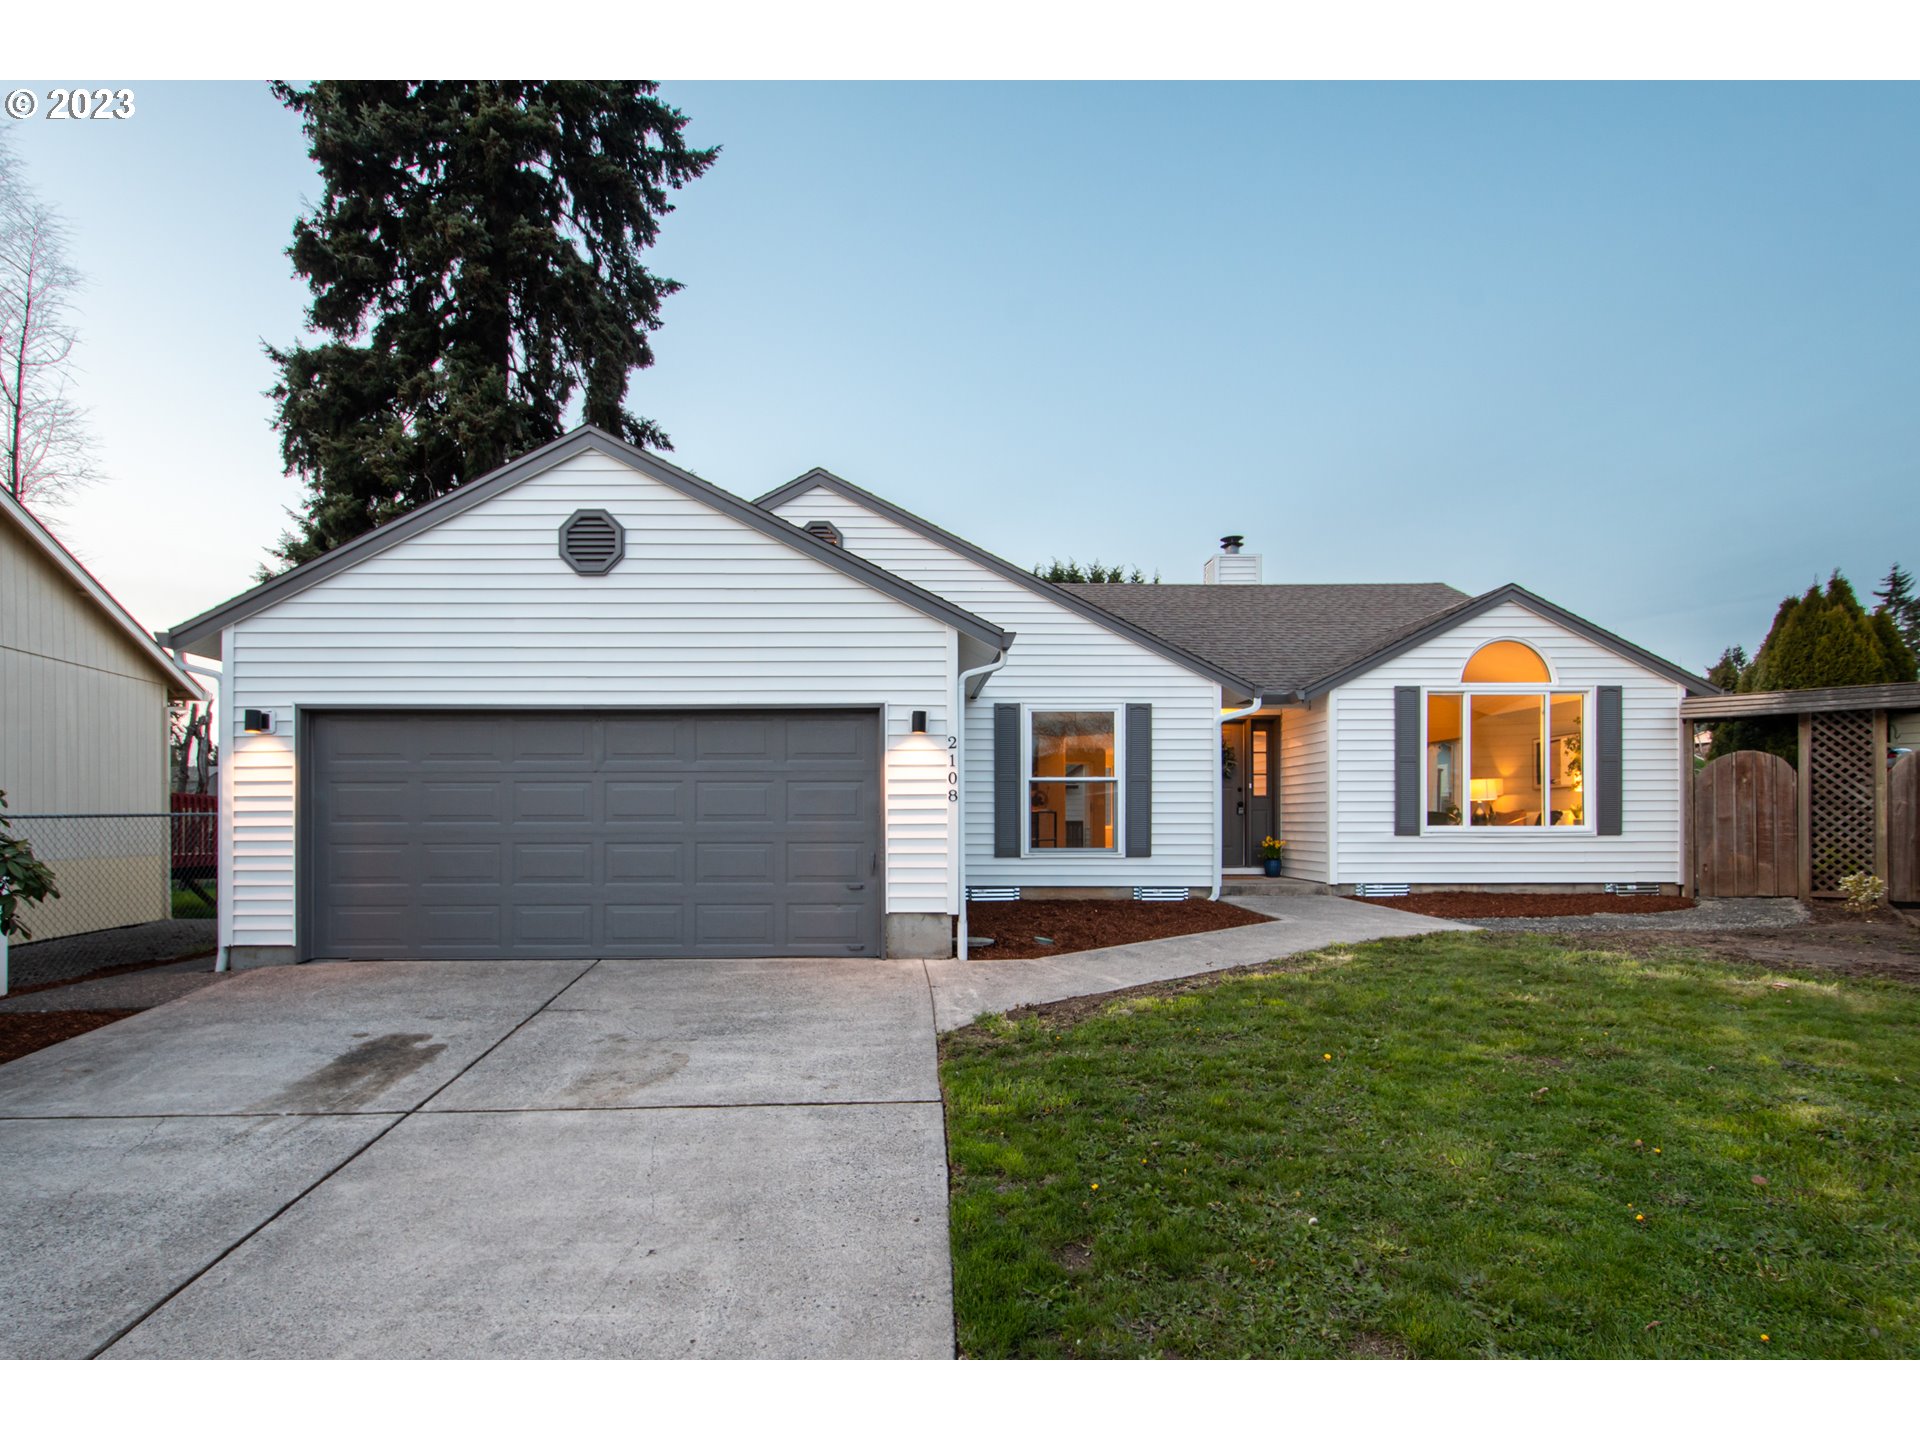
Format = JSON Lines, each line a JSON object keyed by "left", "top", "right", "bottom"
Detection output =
{"left": 8, "top": 817, "right": 219, "bottom": 943}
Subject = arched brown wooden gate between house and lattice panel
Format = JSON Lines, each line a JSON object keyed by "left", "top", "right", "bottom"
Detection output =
{"left": 1693, "top": 751, "right": 1799, "bottom": 899}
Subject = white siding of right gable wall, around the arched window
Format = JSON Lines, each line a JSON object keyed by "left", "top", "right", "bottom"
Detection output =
{"left": 1332, "top": 605, "right": 1686, "bottom": 885}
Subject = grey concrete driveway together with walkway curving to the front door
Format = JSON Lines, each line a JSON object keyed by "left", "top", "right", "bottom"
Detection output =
{"left": 0, "top": 897, "right": 1457, "bottom": 1357}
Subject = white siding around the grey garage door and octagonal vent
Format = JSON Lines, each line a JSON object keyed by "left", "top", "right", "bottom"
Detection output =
{"left": 223, "top": 451, "right": 958, "bottom": 945}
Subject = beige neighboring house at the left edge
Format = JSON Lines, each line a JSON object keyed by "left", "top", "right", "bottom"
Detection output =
{"left": 0, "top": 492, "right": 205, "bottom": 941}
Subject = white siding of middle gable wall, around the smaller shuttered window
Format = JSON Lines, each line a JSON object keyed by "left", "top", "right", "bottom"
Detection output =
{"left": 776, "top": 490, "right": 1219, "bottom": 887}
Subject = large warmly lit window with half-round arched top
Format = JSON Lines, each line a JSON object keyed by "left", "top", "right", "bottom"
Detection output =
{"left": 1427, "top": 639, "right": 1592, "bottom": 829}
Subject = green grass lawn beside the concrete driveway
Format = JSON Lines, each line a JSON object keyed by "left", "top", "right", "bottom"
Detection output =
{"left": 941, "top": 935, "right": 1920, "bottom": 1357}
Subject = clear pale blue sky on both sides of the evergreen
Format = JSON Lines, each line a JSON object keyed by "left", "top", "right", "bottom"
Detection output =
{"left": 6, "top": 83, "right": 1920, "bottom": 666}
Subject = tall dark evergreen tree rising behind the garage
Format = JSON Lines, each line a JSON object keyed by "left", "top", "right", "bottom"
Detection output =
{"left": 267, "top": 81, "right": 718, "bottom": 564}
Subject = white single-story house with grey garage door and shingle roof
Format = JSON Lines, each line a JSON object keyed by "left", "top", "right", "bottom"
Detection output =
{"left": 159, "top": 428, "right": 1709, "bottom": 962}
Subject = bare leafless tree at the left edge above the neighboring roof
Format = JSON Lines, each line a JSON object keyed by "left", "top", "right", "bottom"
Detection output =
{"left": 0, "top": 128, "right": 98, "bottom": 516}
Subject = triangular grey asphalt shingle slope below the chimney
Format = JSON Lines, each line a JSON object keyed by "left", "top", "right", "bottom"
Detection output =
{"left": 1060, "top": 584, "right": 1469, "bottom": 695}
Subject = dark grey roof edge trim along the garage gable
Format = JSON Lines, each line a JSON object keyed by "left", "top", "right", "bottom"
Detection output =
{"left": 159, "top": 424, "right": 1014, "bottom": 655}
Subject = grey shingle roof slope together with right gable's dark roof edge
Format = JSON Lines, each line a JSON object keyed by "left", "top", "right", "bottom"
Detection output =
{"left": 1066, "top": 584, "right": 1718, "bottom": 703}
